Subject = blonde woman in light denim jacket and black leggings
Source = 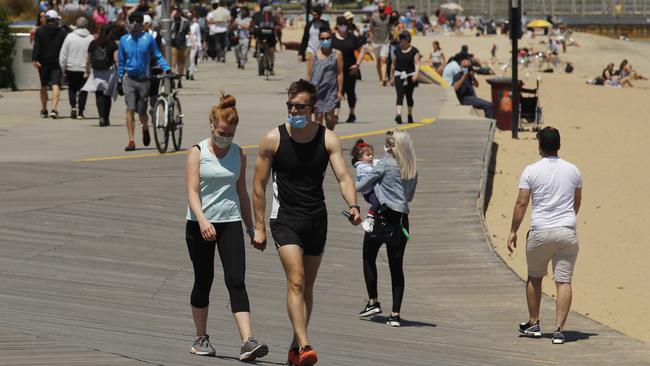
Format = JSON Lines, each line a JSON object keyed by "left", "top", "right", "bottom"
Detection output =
{"left": 356, "top": 129, "right": 418, "bottom": 327}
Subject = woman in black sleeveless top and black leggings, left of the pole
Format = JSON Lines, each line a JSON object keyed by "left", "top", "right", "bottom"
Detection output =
{"left": 390, "top": 31, "right": 421, "bottom": 124}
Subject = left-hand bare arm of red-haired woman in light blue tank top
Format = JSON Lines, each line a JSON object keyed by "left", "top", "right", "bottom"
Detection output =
{"left": 185, "top": 147, "right": 217, "bottom": 241}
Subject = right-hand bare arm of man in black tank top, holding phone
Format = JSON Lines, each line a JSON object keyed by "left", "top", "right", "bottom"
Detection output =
{"left": 325, "top": 130, "right": 361, "bottom": 226}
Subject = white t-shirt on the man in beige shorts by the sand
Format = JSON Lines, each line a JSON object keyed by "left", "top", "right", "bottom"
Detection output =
{"left": 519, "top": 157, "right": 582, "bottom": 229}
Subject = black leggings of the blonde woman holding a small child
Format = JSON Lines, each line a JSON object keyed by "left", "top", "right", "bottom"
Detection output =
{"left": 363, "top": 209, "right": 409, "bottom": 313}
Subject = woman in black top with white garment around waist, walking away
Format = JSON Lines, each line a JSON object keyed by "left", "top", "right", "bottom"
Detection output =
{"left": 82, "top": 25, "right": 117, "bottom": 127}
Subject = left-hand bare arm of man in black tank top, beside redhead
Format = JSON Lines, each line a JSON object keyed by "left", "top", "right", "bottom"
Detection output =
{"left": 253, "top": 129, "right": 280, "bottom": 250}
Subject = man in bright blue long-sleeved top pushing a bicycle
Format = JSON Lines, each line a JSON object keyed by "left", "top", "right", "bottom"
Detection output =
{"left": 117, "top": 13, "right": 171, "bottom": 151}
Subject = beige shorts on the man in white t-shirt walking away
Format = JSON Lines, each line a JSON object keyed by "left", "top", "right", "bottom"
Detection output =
{"left": 526, "top": 227, "right": 580, "bottom": 283}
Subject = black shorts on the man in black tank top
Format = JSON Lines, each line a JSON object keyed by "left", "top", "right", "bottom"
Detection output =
{"left": 270, "top": 215, "right": 327, "bottom": 257}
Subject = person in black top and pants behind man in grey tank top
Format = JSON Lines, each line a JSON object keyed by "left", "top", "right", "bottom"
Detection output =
{"left": 332, "top": 16, "right": 365, "bottom": 123}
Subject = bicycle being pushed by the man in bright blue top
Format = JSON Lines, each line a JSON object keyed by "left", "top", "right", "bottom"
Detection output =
{"left": 153, "top": 74, "right": 183, "bottom": 154}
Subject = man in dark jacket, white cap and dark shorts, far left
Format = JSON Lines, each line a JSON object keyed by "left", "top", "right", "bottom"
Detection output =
{"left": 32, "top": 10, "right": 68, "bottom": 119}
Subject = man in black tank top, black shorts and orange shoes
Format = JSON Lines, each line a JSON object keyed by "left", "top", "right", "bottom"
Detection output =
{"left": 253, "top": 80, "right": 361, "bottom": 365}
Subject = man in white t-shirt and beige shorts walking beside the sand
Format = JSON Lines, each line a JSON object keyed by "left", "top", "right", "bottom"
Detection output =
{"left": 508, "top": 126, "right": 582, "bottom": 344}
